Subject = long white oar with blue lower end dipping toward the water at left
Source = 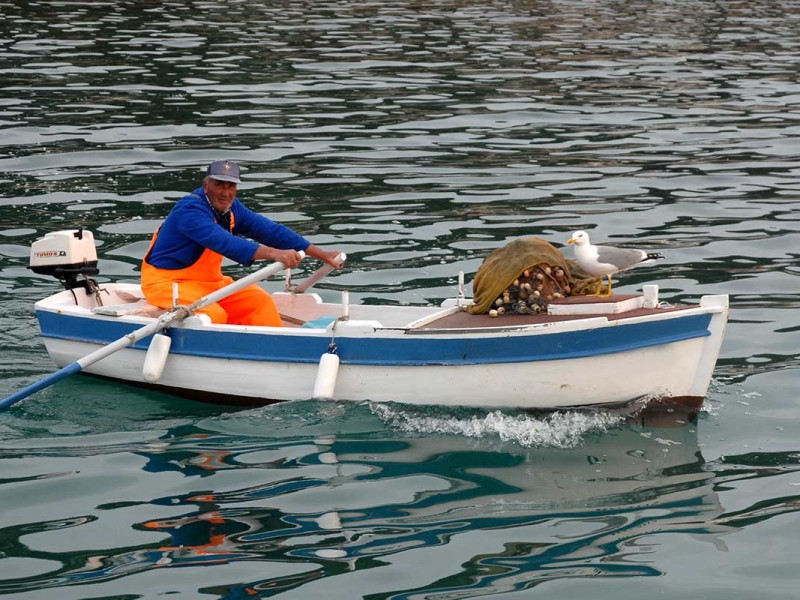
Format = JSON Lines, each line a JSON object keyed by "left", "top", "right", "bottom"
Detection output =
{"left": 0, "top": 252, "right": 305, "bottom": 410}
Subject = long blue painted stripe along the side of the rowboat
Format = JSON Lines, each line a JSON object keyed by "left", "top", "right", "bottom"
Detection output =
{"left": 37, "top": 311, "right": 711, "bottom": 366}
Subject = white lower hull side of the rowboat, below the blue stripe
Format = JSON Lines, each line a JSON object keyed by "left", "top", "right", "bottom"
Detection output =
{"left": 47, "top": 340, "right": 706, "bottom": 409}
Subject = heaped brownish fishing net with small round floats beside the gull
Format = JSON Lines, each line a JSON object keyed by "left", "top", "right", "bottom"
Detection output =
{"left": 467, "top": 237, "right": 602, "bottom": 316}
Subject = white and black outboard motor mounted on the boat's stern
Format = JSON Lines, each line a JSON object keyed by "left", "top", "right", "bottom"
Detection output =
{"left": 29, "top": 229, "right": 100, "bottom": 294}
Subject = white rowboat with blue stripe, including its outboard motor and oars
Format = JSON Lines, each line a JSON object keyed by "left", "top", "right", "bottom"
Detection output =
{"left": 7, "top": 230, "right": 728, "bottom": 410}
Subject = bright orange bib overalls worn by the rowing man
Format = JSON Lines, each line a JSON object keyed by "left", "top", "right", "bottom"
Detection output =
{"left": 142, "top": 220, "right": 282, "bottom": 327}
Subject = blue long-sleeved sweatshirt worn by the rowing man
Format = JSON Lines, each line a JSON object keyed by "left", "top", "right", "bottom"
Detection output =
{"left": 146, "top": 187, "right": 311, "bottom": 270}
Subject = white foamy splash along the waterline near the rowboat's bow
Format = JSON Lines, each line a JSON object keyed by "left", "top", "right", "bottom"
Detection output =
{"left": 370, "top": 403, "right": 626, "bottom": 448}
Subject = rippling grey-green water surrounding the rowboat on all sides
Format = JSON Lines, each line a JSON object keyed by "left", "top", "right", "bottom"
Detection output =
{"left": 0, "top": 0, "right": 800, "bottom": 600}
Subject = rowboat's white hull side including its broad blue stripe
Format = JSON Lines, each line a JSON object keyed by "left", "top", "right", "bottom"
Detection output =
{"left": 37, "top": 284, "right": 727, "bottom": 409}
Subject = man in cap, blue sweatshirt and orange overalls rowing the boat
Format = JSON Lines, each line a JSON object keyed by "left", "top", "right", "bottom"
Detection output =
{"left": 142, "top": 160, "right": 340, "bottom": 327}
